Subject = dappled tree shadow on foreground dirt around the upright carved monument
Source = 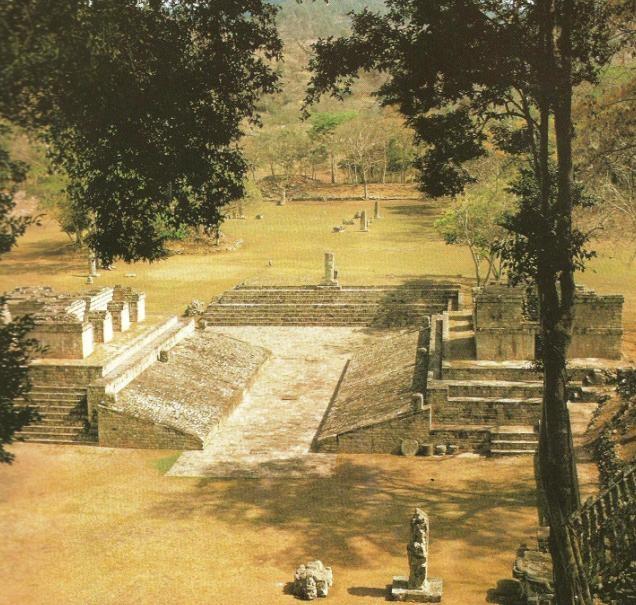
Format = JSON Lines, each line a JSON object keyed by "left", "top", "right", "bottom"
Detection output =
{"left": 148, "top": 460, "right": 535, "bottom": 567}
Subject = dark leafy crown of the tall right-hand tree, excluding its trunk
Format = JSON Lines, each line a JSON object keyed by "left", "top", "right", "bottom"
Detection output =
{"left": 306, "top": 0, "right": 611, "bottom": 197}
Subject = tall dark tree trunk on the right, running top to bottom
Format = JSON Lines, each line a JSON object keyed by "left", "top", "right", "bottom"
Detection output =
{"left": 537, "top": 0, "right": 592, "bottom": 605}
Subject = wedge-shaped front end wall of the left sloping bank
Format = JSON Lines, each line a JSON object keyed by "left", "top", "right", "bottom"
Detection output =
{"left": 97, "top": 406, "right": 203, "bottom": 450}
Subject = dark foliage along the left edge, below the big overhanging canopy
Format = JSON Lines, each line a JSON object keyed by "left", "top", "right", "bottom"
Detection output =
{"left": 0, "top": 125, "right": 37, "bottom": 464}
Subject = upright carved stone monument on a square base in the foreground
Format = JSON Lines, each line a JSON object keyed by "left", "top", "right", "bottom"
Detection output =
{"left": 389, "top": 508, "right": 442, "bottom": 603}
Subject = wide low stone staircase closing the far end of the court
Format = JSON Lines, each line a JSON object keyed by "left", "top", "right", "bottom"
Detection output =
{"left": 203, "top": 283, "right": 459, "bottom": 327}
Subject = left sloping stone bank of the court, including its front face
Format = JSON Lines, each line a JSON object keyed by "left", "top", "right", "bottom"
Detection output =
{"left": 99, "top": 332, "right": 269, "bottom": 449}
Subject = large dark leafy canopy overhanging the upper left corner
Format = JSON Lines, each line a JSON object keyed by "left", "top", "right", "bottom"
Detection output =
{"left": 0, "top": 0, "right": 281, "bottom": 261}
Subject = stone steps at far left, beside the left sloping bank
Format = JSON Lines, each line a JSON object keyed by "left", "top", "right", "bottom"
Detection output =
{"left": 15, "top": 385, "right": 97, "bottom": 444}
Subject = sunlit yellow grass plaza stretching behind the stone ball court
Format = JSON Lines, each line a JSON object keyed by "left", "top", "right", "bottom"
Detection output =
{"left": 0, "top": 185, "right": 636, "bottom": 353}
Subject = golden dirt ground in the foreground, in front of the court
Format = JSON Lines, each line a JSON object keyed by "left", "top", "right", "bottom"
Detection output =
{"left": 0, "top": 444, "right": 548, "bottom": 605}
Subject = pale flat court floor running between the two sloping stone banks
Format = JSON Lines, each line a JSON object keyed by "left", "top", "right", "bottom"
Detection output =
{"left": 169, "top": 327, "right": 370, "bottom": 477}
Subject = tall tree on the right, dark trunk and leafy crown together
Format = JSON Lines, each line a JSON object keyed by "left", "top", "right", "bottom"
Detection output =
{"left": 307, "top": 0, "right": 612, "bottom": 605}
